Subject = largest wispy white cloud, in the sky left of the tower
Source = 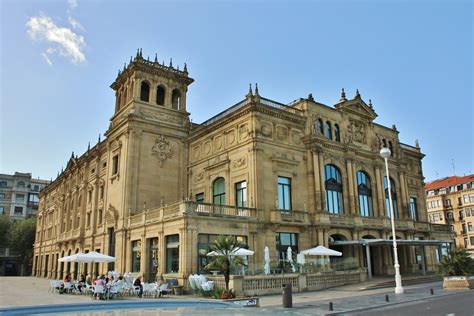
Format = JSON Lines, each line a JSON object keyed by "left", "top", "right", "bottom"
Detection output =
{"left": 26, "top": 16, "right": 86, "bottom": 65}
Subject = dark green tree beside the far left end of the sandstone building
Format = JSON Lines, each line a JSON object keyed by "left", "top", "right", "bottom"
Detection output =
{"left": 8, "top": 218, "right": 36, "bottom": 275}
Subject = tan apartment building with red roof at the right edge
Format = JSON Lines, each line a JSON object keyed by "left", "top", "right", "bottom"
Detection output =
{"left": 425, "top": 174, "right": 474, "bottom": 257}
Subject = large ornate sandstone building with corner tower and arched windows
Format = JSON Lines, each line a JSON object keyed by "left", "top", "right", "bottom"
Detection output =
{"left": 34, "top": 51, "right": 450, "bottom": 282}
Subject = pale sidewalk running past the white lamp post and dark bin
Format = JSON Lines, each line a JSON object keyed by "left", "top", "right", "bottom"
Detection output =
{"left": 260, "top": 282, "right": 468, "bottom": 315}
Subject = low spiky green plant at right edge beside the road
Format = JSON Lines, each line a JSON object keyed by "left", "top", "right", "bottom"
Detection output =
{"left": 438, "top": 248, "right": 474, "bottom": 276}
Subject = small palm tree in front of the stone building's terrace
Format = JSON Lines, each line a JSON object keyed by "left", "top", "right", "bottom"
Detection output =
{"left": 204, "top": 235, "right": 244, "bottom": 290}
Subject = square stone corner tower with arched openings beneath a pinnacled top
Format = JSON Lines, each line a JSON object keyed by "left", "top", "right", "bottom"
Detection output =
{"left": 106, "top": 49, "right": 194, "bottom": 215}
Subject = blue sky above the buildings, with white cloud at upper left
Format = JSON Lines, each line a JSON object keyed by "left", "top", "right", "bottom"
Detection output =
{"left": 0, "top": 0, "right": 474, "bottom": 181}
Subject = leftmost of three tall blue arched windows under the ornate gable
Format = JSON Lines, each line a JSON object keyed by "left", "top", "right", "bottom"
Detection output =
{"left": 324, "top": 165, "right": 344, "bottom": 214}
